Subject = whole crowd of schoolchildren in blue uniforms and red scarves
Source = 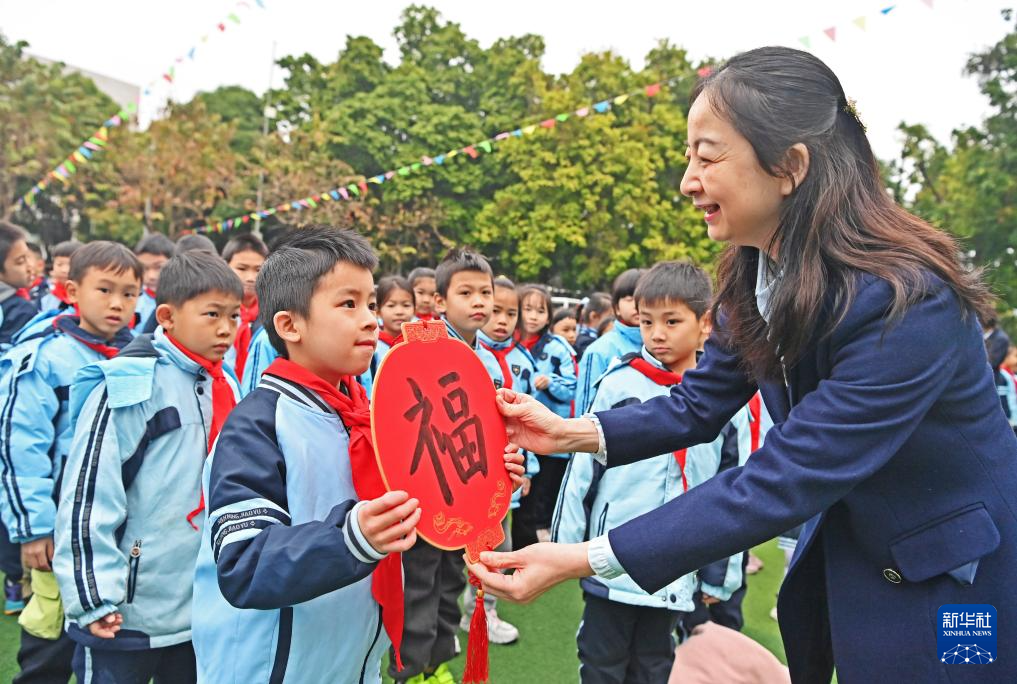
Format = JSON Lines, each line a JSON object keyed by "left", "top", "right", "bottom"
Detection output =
{"left": 17, "top": 216, "right": 1017, "bottom": 684}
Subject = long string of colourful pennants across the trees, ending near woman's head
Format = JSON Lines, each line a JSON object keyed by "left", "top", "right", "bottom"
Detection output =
{"left": 193, "top": 76, "right": 683, "bottom": 233}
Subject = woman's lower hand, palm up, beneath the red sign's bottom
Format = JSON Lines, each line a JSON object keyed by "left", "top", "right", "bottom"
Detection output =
{"left": 463, "top": 543, "right": 593, "bottom": 604}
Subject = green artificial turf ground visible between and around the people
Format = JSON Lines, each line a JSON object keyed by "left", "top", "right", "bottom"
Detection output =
{"left": 0, "top": 542, "right": 784, "bottom": 684}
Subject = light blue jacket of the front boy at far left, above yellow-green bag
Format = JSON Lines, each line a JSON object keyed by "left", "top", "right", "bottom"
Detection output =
{"left": 0, "top": 316, "right": 132, "bottom": 544}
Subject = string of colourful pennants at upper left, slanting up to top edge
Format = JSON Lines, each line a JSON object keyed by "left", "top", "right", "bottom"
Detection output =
{"left": 21, "top": 0, "right": 265, "bottom": 205}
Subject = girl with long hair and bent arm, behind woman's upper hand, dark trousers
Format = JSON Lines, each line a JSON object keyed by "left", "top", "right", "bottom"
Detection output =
{"left": 513, "top": 286, "right": 578, "bottom": 548}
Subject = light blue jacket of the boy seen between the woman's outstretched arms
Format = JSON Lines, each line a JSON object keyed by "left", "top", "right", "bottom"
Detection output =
{"left": 551, "top": 348, "right": 752, "bottom": 611}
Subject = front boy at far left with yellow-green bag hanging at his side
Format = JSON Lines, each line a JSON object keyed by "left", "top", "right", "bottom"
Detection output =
{"left": 0, "top": 242, "right": 141, "bottom": 682}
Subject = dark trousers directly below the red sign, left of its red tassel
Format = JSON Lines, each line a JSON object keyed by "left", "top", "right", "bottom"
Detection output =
{"left": 388, "top": 539, "right": 466, "bottom": 681}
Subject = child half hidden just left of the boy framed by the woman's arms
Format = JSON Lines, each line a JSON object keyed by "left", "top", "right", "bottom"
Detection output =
{"left": 576, "top": 268, "right": 646, "bottom": 416}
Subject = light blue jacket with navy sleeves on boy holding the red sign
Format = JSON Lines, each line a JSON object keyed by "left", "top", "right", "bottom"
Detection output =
{"left": 193, "top": 375, "right": 390, "bottom": 684}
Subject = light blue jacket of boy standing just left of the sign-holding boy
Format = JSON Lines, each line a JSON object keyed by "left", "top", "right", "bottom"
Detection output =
{"left": 53, "top": 329, "right": 237, "bottom": 650}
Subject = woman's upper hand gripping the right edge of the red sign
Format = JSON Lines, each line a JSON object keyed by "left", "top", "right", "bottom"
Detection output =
{"left": 497, "top": 388, "right": 600, "bottom": 454}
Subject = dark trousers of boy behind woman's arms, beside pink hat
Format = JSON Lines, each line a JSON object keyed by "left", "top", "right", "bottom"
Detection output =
{"left": 576, "top": 594, "right": 678, "bottom": 684}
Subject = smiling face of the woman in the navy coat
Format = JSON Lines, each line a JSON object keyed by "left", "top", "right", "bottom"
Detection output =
{"left": 680, "top": 92, "right": 793, "bottom": 249}
